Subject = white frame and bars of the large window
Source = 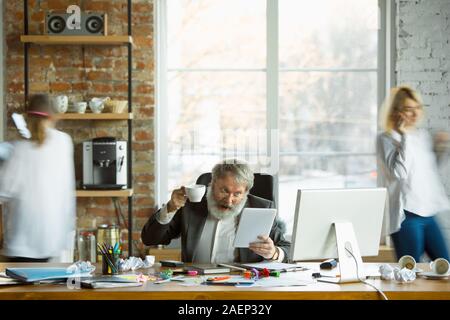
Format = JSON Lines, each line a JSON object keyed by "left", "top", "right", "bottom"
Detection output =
{"left": 154, "top": 0, "right": 395, "bottom": 214}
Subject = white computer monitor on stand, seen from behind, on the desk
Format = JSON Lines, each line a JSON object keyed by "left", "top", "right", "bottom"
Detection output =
{"left": 290, "top": 188, "right": 386, "bottom": 282}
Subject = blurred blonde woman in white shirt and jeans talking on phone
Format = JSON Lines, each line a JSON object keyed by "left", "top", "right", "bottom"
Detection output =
{"left": 377, "top": 86, "right": 450, "bottom": 261}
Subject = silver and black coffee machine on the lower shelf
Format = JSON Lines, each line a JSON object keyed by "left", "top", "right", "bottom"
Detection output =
{"left": 83, "top": 137, "right": 128, "bottom": 189}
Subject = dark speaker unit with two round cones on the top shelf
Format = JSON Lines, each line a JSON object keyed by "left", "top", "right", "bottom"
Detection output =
{"left": 45, "top": 12, "right": 107, "bottom": 36}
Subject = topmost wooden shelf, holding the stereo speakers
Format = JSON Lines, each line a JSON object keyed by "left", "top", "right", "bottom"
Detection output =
{"left": 20, "top": 35, "right": 133, "bottom": 45}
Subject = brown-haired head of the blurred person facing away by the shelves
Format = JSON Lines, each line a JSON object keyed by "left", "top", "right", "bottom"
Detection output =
{"left": 27, "top": 94, "right": 53, "bottom": 146}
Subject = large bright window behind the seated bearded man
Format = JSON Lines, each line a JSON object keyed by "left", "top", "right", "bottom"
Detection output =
{"left": 157, "top": 0, "right": 384, "bottom": 233}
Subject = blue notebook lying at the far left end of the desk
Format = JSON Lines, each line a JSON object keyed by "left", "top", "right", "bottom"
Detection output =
{"left": 5, "top": 268, "right": 90, "bottom": 282}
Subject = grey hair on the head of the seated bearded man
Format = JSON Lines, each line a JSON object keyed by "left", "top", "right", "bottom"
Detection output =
{"left": 212, "top": 159, "right": 254, "bottom": 190}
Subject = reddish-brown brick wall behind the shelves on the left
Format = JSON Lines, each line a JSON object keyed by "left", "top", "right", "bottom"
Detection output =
{"left": 3, "top": 0, "right": 155, "bottom": 253}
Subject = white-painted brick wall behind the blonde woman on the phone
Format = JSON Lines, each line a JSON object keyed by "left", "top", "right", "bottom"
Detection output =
{"left": 396, "top": 0, "right": 450, "bottom": 248}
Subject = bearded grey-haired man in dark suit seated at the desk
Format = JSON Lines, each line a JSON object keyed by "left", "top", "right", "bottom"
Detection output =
{"left": 141, "top": 159, "right": 290, "bottom": 263}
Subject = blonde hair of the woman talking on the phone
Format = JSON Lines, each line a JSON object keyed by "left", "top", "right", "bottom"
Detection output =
{"left": 380, "top": 85, "right": 423, "bottom": 132}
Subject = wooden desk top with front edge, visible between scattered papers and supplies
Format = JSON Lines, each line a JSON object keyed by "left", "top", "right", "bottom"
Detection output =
{"left": 0, "top": 263, "right": 450, "bottom": 300}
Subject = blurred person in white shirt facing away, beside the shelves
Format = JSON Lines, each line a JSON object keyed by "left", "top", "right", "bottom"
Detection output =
{"left": 0, "top": 94, "right": 76, "bottom": 262}
